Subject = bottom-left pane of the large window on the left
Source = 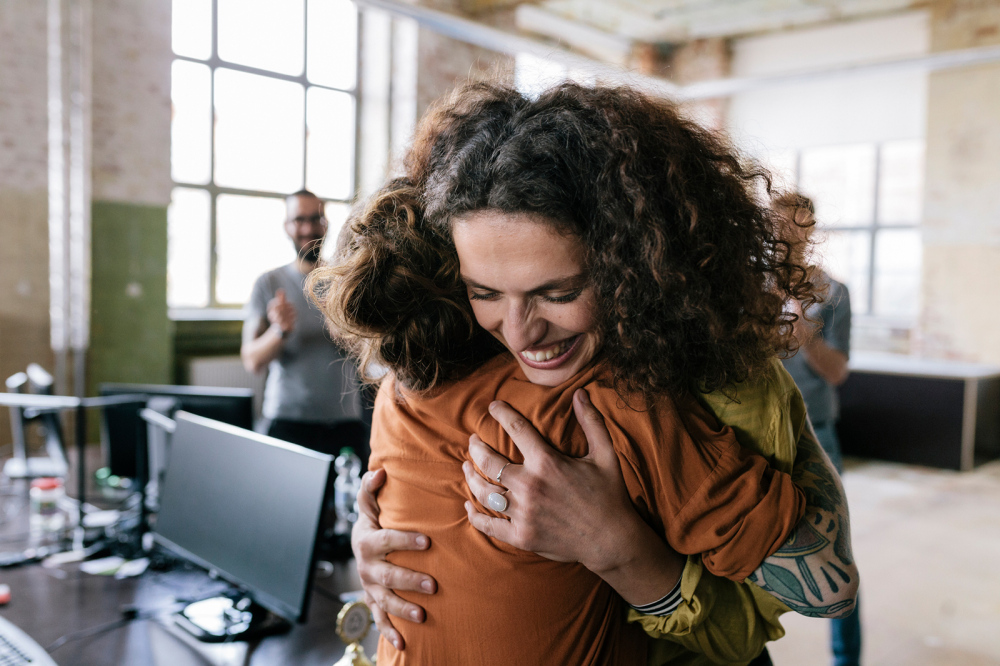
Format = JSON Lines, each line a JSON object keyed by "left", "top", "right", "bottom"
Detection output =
{"left": 167, "top": 187, "right": 212, "bottom": 308}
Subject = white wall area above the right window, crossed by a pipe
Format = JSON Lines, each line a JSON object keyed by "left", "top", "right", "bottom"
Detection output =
{"left": 727, "top": 12, "right": 930, "bottom": 158}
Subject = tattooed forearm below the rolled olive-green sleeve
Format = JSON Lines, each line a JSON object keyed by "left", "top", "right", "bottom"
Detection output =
{"left": 749, "top": 426, "right": 858, "bottom": 617}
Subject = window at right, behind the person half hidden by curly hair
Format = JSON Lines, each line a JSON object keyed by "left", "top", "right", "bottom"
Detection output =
{"left": 772, "top": 140, "right": 924, "bottom": 329}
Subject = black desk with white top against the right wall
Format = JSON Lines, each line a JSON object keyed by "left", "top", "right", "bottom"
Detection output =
{"left": 838, "top": 352, "right": 1000, "bottom": 470}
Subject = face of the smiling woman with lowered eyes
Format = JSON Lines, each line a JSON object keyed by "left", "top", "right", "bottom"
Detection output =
{"left": 452, "top": 210, "right": 599, "bottom": 386}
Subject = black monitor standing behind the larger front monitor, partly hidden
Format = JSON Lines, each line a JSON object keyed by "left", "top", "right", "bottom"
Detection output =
{"left": 98, "top": 384, "right": 253, "bottom": 478}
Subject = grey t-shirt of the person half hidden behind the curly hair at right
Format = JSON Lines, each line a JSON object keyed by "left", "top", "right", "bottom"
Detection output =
{"left": 784, "top": 273, "right": 851, "bottom": 425}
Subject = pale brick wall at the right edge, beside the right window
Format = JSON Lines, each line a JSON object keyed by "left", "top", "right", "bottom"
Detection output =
{"left": 922, "top": 0, "right": 1000, "bottom": 363}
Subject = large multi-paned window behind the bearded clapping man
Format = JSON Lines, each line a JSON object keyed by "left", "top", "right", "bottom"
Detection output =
{"left": 167, "top": 0, "right": 358, "bottom": 308}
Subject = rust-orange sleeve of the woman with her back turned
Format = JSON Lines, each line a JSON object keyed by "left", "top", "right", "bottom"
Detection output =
{"left": 600, "top": 400, "right": 805, "bottom": 582}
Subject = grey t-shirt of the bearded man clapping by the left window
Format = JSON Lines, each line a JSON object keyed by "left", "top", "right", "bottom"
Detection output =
{"left": 243, "top": 262, "right": 361, "bottom": 423}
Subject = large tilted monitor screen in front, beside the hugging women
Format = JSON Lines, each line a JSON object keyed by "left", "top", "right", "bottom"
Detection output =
{"left": 154, "top": 412, "right": 333, "bottom": 622}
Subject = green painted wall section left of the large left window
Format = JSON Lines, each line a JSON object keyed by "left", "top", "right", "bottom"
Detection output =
{"left": 87, "top": 201, "right": 173, "bottom": 395}
